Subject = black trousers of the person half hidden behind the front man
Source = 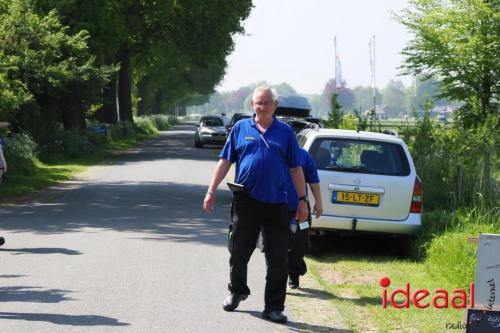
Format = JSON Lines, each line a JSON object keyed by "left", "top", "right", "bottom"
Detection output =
{"left": 288, "top": 210, "right": 311, "bottom": 277}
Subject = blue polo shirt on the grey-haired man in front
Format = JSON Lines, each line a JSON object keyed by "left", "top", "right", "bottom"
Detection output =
{"left": 219, "top": 115, "right": 300, "bottom": 203}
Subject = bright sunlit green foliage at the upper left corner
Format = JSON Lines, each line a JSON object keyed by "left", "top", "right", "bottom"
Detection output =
{"left": 0, "top": 0, "right": 109, "bottom": 132}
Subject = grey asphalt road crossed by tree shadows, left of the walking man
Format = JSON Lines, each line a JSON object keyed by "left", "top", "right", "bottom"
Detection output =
{"left": 0, "top": 125, "right": 301, "bottom": 332}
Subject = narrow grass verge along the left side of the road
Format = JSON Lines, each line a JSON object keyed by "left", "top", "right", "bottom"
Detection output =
{"left": 0, "top": 133, "right": 158, "bottom": 198}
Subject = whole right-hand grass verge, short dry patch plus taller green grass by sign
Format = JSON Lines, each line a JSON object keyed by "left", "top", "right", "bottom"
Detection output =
{"left": 307, "top": 207, "right": 500, "bottom": 332}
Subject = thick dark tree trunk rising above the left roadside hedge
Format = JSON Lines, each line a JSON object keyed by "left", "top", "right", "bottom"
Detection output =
{"left": 118, "top": 45, "right": 134, "bottom": 122}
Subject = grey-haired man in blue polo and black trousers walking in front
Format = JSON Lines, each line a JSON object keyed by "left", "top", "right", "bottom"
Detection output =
{"left": 203, "top": 86, "right": 308, "bottom": 323}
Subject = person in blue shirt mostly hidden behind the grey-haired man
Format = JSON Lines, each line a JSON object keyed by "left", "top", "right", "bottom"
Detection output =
{"left": 288, "top": 148, "right": 323, "bottom": 289}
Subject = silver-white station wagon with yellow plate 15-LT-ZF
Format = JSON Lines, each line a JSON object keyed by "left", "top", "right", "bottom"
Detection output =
{"left": 298, "top": 128, "right": 422, "bottom": 251}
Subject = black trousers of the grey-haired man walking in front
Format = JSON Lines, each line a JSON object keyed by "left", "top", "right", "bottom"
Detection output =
{"left": 228, "top": 192, "right": 289, "bottom": 311}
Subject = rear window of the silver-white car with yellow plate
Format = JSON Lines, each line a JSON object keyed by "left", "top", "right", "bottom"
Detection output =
{"left": 310, "top": 138, "right": 410, "bottom": 176}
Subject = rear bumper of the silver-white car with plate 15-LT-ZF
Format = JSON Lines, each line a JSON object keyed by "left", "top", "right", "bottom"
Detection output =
{"left": 312, "top": 214, "right": 422, "bottom": 235}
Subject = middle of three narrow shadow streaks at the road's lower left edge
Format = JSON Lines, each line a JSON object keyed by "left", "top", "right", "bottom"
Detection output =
{"left": 0, "top": 286, "right": 74, "bottom": 303}
